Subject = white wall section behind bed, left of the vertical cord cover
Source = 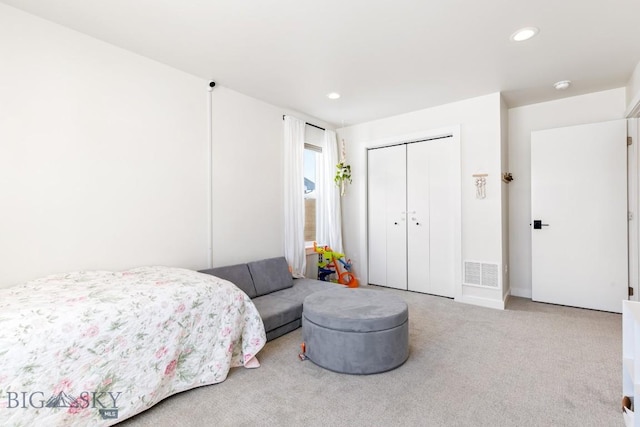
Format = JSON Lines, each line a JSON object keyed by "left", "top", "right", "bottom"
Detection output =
{"left": 0, "top": 5, "right": 207, "bottom": 287}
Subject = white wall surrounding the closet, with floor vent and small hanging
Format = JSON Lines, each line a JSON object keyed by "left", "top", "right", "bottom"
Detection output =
{"left": 338, "top": 93, "right": 503, "bottom": 307}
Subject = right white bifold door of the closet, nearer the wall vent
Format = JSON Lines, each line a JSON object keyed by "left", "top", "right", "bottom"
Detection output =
{"left": 407, "top": 138, "right": 459, "bottom": 297}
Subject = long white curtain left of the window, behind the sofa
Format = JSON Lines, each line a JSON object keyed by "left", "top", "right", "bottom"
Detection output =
{"left": 284, "top": 116, "right": 307, "bottom": 277}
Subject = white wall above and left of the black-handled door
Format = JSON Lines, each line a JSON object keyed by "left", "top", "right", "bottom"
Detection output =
{"left": 509, "top": 88, "right": 625, "bottom": 298}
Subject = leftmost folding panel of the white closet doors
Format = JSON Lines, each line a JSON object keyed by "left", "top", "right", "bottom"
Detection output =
{"left": 367, "top": 149, "right": 388, "bottom": 285}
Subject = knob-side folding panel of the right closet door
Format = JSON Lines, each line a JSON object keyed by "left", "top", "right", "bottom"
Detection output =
{"left": 407, "top": 141, "right": 431, "bottom": 292}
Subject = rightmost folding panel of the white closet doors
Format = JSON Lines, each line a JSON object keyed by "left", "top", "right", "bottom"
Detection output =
{"left": 429, "top": 138, "right": 460, "bottom": 297}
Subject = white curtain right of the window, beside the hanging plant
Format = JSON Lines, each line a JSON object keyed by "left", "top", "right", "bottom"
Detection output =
{"left": 316, "top": 130, "right": 342, "bottom": 253}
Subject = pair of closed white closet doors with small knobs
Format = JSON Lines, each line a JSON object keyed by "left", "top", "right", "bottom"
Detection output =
{"left": 367, "top": 136, "right": 460, "bottom": 297}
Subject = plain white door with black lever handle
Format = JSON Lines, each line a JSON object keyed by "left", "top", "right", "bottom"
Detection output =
{"left": 531, "top": 120, "right": 628, "bottom": 313}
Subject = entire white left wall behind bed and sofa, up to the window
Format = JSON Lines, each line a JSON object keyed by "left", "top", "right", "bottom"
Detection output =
{"left": 0, "top": 5, "right": 327, "bottom": 287}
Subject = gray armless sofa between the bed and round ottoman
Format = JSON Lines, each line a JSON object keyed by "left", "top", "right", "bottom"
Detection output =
{"left": 200, "top": 257, "right": 341, "bottom": 341}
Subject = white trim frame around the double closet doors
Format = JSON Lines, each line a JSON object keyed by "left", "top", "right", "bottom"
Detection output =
{"left": 364, "top": 125, "right": 462, "bottom": 301}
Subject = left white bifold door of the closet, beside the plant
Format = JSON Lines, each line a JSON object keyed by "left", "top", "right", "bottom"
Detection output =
{"left": 368, "top": 145, "right": 407, "bottom": 289}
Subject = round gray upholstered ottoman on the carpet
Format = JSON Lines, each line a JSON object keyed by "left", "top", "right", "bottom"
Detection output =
{"left": 302, "top": 287, "right": 409, "bottom": 374}
